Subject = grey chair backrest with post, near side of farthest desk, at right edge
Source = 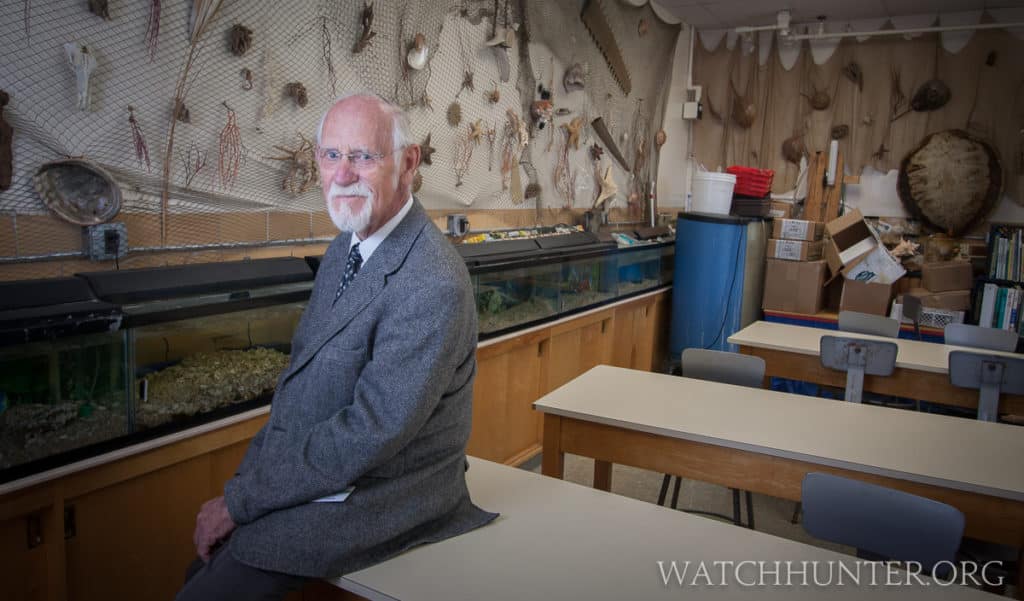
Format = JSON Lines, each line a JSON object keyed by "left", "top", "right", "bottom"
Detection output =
{"left": 949, "top": 350, "right": 1024, "bottom": 422}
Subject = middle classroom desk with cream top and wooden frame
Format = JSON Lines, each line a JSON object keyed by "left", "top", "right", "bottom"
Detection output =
{"left": 534, "top": 366, "right": 1024, "bottom": 593}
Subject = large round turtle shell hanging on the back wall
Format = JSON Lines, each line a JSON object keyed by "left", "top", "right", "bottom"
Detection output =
{"left": 896, "top": 129, "right": 1002, "bottom": 235}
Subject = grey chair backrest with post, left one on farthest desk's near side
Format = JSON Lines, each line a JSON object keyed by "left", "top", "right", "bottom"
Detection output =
{"left": 818, "top": 336, "right": 899, "bottom": 402}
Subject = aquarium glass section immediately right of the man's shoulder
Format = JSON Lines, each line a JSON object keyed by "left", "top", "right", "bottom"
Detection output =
{"left": 473, "top": 264, "right": 561, "bottom": 335}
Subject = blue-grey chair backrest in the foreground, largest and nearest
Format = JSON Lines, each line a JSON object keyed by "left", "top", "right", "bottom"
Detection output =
{"left": 801, "top": 472, "right": 964, "bottom": 571}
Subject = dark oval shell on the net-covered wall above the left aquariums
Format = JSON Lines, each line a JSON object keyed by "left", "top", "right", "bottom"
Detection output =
{"left": 33, "top": 159, "right": 121, "bottom": 225}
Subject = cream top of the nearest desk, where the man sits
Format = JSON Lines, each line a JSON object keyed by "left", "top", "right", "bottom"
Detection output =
{"left": 331, "top": 458, "right": 994, "bottom": 601}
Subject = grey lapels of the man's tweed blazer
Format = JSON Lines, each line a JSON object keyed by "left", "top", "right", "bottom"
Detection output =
{"left": 285, "top": 200, "right": 429, "bottom": 381}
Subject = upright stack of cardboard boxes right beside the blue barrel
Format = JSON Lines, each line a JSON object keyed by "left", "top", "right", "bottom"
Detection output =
{"left": 762, "top": 219, "right": 825, "bottom": 314}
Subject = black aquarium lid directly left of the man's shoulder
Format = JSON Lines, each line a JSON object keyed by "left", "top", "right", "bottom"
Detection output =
{"left": 77, "top": 257, "right": 313, "bottom": 303}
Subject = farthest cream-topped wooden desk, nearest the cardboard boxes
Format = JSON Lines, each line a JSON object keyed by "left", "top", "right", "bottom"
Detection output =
{"left": 729, "top": 321, "right": 1024, "bottom": 415}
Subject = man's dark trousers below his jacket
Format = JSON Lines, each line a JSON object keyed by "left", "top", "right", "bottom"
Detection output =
{"left": 175, "top": 545, "right": 306, "bottom": 601}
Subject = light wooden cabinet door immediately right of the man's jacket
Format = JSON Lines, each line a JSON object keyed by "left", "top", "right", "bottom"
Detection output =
{"left": 467, "top": 329, "right": 550, "bottom": 464}
